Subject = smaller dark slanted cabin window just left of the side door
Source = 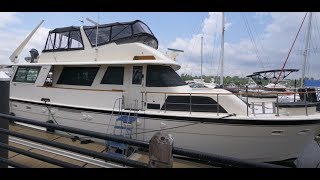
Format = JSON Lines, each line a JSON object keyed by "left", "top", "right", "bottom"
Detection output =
{"left": 101, "top": 66, "right": 124, "bottom": 85}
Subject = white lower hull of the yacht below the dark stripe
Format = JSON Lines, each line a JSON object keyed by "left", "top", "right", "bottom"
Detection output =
{"left": 11, "top": 100, "right": 320, "bottom": 162}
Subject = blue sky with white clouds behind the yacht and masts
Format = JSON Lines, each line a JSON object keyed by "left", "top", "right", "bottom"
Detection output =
{"left": 0, "top": 12, "right": 320, "bottom": 79}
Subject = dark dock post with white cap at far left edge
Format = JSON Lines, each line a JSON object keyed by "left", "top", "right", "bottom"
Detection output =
{"left": 0, "top": 74, "right": 10, "bottom": 168}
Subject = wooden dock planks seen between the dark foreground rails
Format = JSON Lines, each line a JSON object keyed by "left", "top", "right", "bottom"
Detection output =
{"left": 8, "top": 124, "right": 214, "bottom": 168}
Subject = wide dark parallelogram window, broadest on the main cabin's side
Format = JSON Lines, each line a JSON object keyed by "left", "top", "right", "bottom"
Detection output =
{"left": 57, "top": 67, "right": 99, "bottom": 86}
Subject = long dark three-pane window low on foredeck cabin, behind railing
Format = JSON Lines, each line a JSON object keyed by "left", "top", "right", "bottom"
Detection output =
{"left": 161, "top": 96, "right": 227, "bottom": 113}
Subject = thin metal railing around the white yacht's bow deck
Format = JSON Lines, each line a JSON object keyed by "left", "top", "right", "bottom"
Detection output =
{"left": 141, "top": 90, "right": 319, "bottom": 116}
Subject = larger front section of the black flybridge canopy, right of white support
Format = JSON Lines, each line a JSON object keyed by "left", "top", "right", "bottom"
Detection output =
{"left": 83, "top": 20, "right": 158, "bottom": 49}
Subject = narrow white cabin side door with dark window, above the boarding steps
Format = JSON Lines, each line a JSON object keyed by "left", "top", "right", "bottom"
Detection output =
{"left": 126, "top": 66, "right": 144, "bottom": 109}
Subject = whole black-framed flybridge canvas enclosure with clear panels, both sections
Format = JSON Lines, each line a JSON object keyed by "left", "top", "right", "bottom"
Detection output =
{"left": 43, "top": 20, "right": 158, "bottom": 52}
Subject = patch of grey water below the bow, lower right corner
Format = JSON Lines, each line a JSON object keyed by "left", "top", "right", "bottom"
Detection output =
{"left": 296, "top": 141, "right": 320, "bottom": 168}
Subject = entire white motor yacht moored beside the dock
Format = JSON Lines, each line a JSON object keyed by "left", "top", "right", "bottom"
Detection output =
{"left": 6, "top": 20, "right": 320, "bottom": 162}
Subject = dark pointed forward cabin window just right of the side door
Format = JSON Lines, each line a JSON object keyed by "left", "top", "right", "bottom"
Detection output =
{"left": 146, "top": 65, "right": 186, "bottom": 87}
